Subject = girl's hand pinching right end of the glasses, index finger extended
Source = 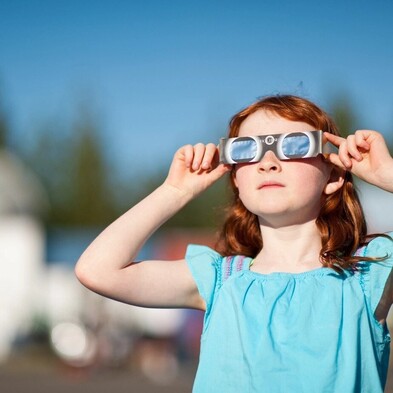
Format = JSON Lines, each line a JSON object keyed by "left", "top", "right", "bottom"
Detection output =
{"left": 324, "top": 130, "right": 393, "bottom": 192}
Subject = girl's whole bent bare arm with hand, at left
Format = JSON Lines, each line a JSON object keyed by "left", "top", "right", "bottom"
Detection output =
{"left": 75, "top": 144, "right": 229, "bottom": 309}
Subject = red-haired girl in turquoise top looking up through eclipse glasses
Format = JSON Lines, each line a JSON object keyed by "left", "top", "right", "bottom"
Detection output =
{"left": 76, "top": 96, "right": 393, "bottom": 393}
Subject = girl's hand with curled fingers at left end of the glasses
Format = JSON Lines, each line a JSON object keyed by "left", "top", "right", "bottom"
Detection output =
{"left": 164, "top": 143, "right": 231, "bottom": 198}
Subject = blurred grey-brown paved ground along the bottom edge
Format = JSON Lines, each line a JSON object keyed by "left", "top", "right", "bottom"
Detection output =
{"left": 0, "top": 344, "right": 393, "bottom": 393}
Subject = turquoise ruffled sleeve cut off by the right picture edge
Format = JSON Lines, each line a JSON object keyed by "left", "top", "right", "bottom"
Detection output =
{"left": 359, "top": 233, "right": 393, "bottom": 313}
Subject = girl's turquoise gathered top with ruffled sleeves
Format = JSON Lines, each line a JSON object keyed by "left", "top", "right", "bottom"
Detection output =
{"left": 186, "top": 237, "right": 393, "bottom": 393}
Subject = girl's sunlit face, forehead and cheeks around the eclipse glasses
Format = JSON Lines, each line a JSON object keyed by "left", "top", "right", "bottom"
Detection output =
{"left": 234, "top": 110, "right": 331, "bottom": 225}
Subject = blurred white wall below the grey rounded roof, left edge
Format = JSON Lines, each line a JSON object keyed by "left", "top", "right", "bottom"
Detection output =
{"left": 0, "top": 215, "right": 45, "bottom": 362}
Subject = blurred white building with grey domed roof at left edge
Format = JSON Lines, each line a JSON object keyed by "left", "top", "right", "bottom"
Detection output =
{"left": 0, "top": 149, "right": 48, "bottom": 362}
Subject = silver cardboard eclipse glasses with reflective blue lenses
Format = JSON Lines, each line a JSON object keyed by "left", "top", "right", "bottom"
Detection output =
{"left": 219, "top": 130, "right": 337, "bottom": 164}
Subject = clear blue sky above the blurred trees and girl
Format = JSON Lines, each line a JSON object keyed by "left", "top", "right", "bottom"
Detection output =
{"left": 0, "top": 0, "right": 393, "bottom": 176}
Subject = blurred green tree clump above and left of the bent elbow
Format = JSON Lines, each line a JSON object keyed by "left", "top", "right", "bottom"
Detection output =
{"left": 29, "top": 102, "right": 116, "bottom": 226}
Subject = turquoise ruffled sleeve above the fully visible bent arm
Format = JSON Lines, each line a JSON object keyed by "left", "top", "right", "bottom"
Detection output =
{"left": 186, "top": 244, "right": 222, "bottom": 312}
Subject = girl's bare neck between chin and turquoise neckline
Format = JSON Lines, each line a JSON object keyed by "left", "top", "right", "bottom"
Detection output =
{"left": 253, "top": 220, "right": 322, "bottom": 274}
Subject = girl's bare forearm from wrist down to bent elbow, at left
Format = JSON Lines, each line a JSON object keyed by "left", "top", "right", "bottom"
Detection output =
{"left": 78, "top": 183, "right": 192, "bottom": 269}
